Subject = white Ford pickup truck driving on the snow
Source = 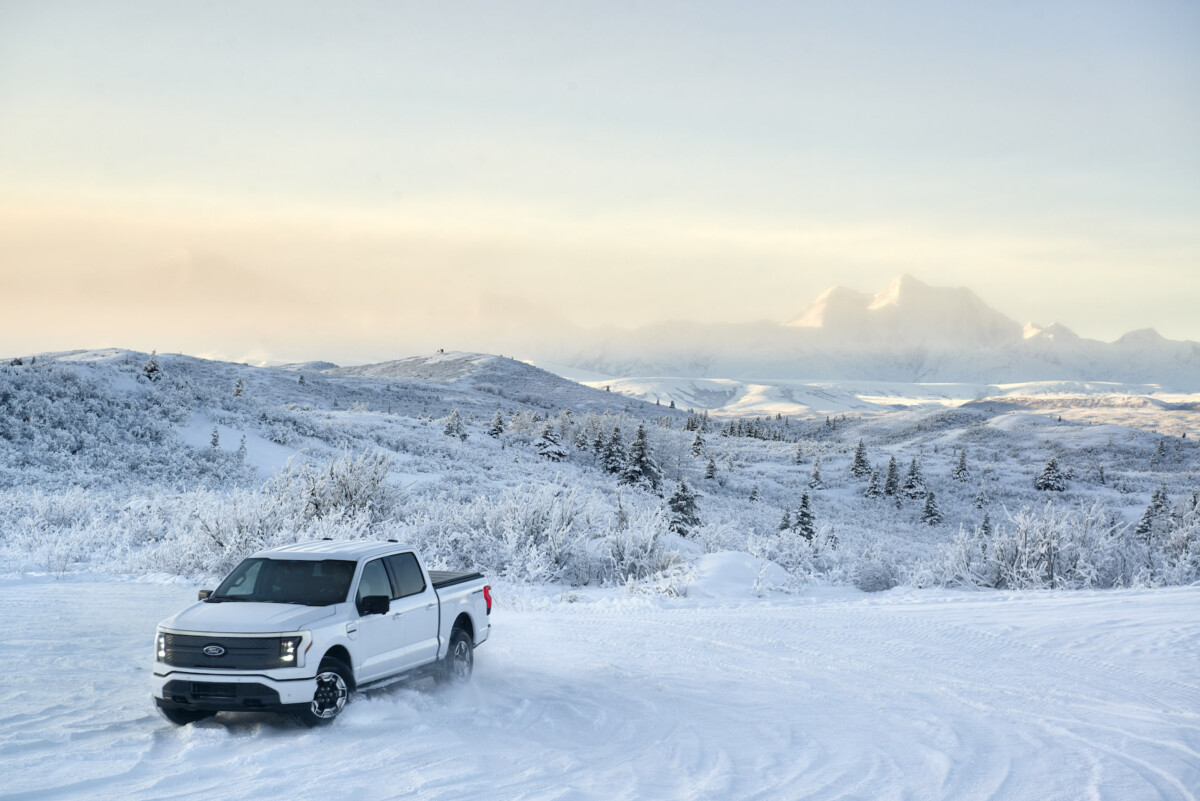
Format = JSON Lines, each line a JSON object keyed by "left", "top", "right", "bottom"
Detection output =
{"left": 154, "top": 541, "right": 492, "bottom": 725}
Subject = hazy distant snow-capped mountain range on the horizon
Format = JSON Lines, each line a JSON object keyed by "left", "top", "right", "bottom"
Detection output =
{"left": 530, "top": 276, "right": 1200, "bottom": 392}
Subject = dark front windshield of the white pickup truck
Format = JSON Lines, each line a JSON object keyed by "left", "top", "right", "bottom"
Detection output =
{"left": 209, "top": 559, "right": 355, "bottom": 607}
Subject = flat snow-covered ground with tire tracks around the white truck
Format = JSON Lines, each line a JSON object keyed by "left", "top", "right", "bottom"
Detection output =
{"left": 0, "top": 571, "right": 1200, "bottom": 801}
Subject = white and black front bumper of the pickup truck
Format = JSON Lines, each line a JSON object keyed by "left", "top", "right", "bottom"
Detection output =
{"left": 151, "top": 670, "right": 317, "bottom": 712}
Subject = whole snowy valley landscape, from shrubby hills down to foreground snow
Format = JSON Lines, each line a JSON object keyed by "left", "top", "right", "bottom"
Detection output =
{"left": 0, "top": 335, "right": 1200, "bottom": 799}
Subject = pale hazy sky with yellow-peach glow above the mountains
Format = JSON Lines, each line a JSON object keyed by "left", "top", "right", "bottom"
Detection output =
{"left": 0, "top": 0, "right": 1200, "bottom": 363}
